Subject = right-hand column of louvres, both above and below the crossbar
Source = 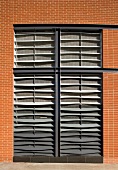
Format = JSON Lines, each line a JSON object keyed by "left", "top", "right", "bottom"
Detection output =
{"left": 60, "top": 31, "right": 101, "bottom": 156}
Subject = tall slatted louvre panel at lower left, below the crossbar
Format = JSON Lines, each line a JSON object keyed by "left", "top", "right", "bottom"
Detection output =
{"left": 14, "top": 74, "right": 55, "bottom": 156}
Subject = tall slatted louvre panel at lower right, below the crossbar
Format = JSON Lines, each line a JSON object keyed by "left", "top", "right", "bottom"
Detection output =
{"left": 60, "top": 74, "right": 102, "bottom": 156}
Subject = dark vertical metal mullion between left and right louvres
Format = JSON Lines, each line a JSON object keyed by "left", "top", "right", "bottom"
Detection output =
{"left": 55, "top": 29, "right": 60, "bottom": 157}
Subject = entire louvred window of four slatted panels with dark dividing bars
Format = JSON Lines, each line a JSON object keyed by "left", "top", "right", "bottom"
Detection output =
{"left": 14, "top": 27, "right": 102, "bottom": 160}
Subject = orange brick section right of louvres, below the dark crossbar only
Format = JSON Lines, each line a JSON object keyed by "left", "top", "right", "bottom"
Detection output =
{"left": 103, "top": 73, "right": 118, "bottom": 163}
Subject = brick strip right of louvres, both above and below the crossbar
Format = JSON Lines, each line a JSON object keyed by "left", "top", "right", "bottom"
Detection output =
{"left": 103, "top": 30, "right": 118, "bottom": 163}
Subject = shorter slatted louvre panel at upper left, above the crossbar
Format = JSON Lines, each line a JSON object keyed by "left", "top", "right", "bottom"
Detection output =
{"left": 14, "top": 30, "right": 55, "bottom": 68}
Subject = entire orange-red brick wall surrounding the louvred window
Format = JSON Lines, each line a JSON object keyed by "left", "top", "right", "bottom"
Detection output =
{"left": 0, "top": 0, "right": 118, "bottom": 163}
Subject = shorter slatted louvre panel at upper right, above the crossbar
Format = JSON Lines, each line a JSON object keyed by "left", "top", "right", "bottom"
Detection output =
{"left": 61, "top": 31, "right": 101, "bottom": 68}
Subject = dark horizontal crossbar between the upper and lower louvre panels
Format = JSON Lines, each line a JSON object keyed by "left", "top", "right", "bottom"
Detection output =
{"left": 13, "top": 67, "right": 118, "bottom": 74}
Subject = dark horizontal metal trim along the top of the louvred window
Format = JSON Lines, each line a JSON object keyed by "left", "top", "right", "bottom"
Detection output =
{"left": 13, "top": 24, "right": 118, "bottom": 31}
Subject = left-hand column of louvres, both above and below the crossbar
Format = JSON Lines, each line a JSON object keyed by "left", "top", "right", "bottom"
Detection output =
{"left": 14, "top": 31, "right": 55, "bottom": 156}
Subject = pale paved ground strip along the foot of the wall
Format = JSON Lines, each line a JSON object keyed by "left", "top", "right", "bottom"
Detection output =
{"left": 0, "top": 163, "right": 118, "bottom": 170}
